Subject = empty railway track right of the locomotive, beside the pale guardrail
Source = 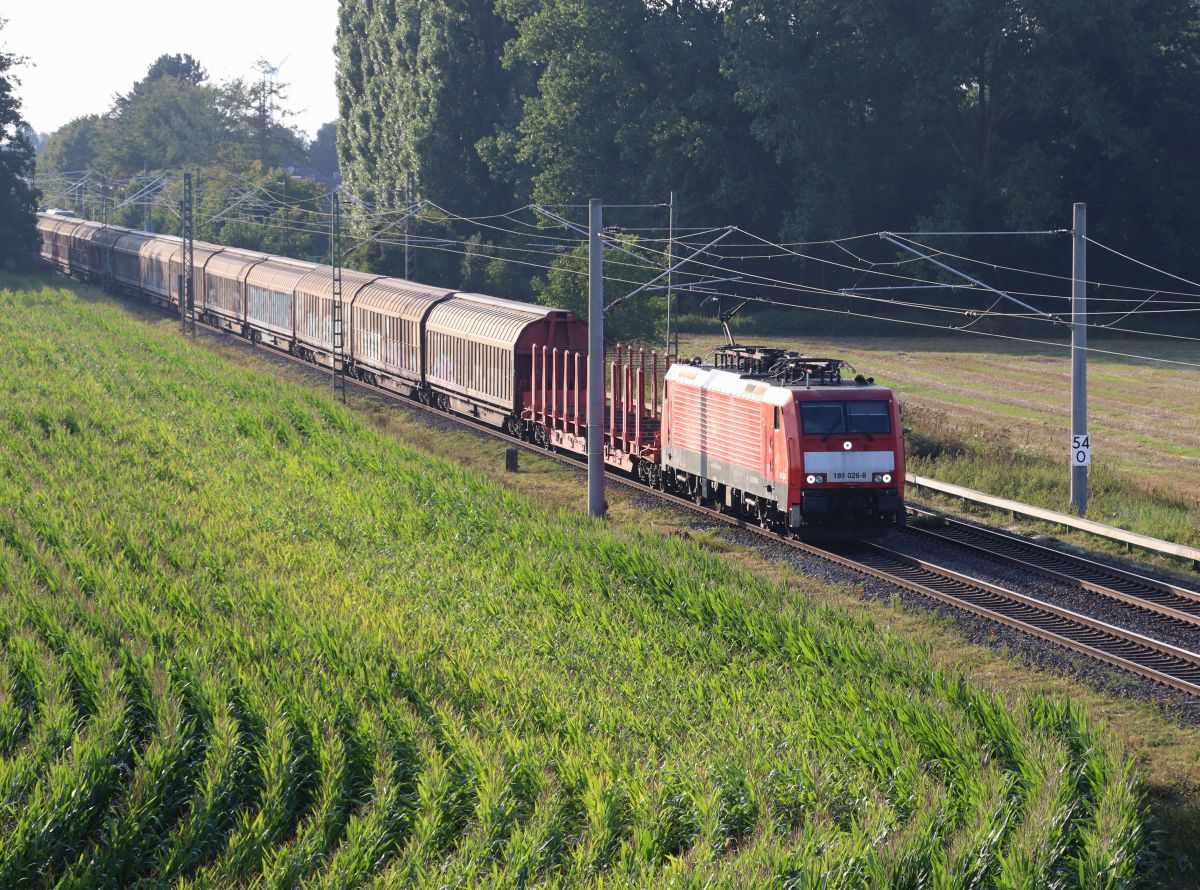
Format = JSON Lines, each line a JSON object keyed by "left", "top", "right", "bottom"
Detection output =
{"left": 908, "top": 504, "right": 1200, "bottom": 629}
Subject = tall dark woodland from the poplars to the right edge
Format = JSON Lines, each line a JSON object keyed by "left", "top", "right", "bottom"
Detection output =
{"left": 337, "top": 0, "right": 1200, "bottom": 335}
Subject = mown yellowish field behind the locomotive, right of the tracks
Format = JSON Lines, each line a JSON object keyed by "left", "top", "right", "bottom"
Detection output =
{"left": 682, "top": 331, "right": 1200, "bottom": 563}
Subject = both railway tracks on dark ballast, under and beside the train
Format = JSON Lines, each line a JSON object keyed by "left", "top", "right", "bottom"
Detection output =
{"left": 187, "top": 316, "right": 1200, "bottom": 696}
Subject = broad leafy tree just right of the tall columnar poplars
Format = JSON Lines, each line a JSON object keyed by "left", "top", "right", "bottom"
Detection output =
{"left": 484, "top": 0, "right": 774, "bottom": 224}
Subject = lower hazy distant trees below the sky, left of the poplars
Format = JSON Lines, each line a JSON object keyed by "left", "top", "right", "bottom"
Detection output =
{"left": 37, "top": 54, "right": 337, "bottom": 258}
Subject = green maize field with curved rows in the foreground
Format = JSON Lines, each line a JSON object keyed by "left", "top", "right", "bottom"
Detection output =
{"left": 0, "top": 280, "right": 1171, "bottom": 888}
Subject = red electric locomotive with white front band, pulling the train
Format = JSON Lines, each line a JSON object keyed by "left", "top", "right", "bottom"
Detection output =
{"left": 661, "top": 344, "right": 905, "bottom": 537}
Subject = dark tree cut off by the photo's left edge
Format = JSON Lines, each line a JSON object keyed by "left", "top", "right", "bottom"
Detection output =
{"left": 0, "top": 19, "right": 40, "bottom": 269}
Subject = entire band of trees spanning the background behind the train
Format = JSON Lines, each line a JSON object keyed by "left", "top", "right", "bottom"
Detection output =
{"left": 9, "top": 6, "right": 1200, "bottom": 338}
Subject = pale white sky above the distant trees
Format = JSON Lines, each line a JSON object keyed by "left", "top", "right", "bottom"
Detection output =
{"left": 0, "top": 0, "right": 337, "bottom": 138}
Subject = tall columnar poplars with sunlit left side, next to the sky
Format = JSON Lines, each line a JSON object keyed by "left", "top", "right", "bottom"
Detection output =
{"left": 337, "top": 0, "right": 523, "bottom": 245}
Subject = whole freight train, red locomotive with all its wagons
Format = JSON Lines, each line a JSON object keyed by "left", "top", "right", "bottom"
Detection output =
{"left": 37, "top": 212, "right": 905, "bottom": 537}
